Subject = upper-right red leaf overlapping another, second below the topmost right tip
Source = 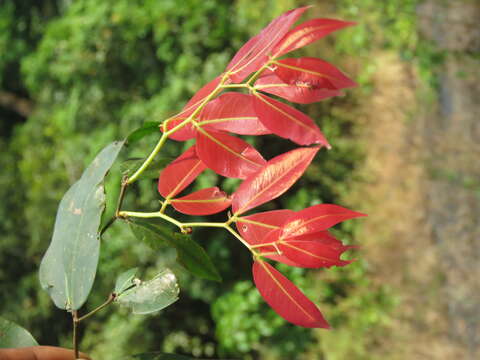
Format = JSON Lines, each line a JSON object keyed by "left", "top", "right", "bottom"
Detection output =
{"left": 274, "top": 57, "right": 357, "bottom": 90}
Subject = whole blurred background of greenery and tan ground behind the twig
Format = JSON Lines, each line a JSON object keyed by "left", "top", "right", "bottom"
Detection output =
{"left": 0, "top": 0, "right": 480, "bottom": 360}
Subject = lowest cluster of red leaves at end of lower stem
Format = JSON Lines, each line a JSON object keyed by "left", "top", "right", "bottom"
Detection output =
{"left": 236, "top": 204, "right": 365, "bottom": 328}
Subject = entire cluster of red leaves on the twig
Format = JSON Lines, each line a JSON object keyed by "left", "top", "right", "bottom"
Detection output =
{"left": 158, "top": 7, "right": 364, "bottom": 328}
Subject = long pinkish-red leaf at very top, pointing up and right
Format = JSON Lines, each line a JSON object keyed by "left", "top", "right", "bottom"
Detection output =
{"left": 227, "top": 7, "right": 308, "bottom": 83}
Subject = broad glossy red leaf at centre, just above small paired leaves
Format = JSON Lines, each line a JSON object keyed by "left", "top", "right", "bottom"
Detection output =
{"left": 197, "top": 129, "right": 266, "bottom": 179}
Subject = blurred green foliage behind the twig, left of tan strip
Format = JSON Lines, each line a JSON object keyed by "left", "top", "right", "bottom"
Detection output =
{"left": 0, "top": 0, "right": 416, "bottom": 360}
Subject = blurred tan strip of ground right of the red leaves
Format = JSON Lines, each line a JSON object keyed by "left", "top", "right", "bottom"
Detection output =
{"left": 354, "top": 53, "right": 467, "bottom": 359}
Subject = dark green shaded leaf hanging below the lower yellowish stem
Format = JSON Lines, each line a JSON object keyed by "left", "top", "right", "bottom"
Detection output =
{"left": 129, "top": 219, "right": 222, "bottom": 281}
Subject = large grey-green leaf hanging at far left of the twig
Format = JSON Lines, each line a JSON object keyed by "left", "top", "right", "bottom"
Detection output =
{"left": 40, "top": 142, "right": 123, "bottom": 310}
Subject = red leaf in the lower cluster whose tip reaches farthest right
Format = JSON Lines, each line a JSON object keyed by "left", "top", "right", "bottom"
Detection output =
{"left": 282, "top": 204, "right": 367, "bottom": 239}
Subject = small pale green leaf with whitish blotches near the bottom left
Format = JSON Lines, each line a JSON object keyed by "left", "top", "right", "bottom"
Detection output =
{"left": 115, "top": 269, "right": 180, "bottom": 314}
